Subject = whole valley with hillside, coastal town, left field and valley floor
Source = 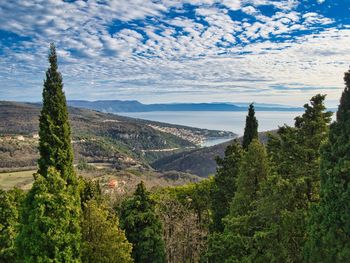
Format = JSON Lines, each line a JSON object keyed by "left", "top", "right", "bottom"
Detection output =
{"left": 0, "top": 101, "right": 236, "bottom": 189}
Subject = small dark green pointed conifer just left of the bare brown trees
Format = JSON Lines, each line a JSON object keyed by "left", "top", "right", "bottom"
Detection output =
{"left": 120, "top": 182, "right": 165, "bottom": 263}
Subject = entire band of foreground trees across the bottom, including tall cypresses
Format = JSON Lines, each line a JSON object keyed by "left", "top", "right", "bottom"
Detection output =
{"left": 0, "top": 45, "right": 350, "bottom": 263}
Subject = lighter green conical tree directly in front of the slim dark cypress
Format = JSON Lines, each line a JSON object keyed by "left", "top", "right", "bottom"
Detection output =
{"left": 207, "top": 139, "right": 269, "bottom": 262}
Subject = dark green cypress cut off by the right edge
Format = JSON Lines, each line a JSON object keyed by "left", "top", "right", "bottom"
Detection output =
{"left": 305, "top": 70, "right": 350, "bottom": 262}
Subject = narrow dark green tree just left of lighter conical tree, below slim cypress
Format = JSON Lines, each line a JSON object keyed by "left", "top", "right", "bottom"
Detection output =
{"left": 211, "top": 140, "right": 243, "bottom": 232}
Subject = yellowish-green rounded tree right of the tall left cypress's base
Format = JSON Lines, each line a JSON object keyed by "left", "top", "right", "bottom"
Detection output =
{"left": 82, "top": 199, "right": 133, "bottom": 263}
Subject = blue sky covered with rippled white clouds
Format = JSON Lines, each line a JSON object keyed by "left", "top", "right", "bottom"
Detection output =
{"left": 0, "top": 0, "right": 350, "bottom": 107}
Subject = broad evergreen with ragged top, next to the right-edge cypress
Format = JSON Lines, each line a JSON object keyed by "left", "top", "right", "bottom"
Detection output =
{"left": 254, "top": 95, "right": 331, "bottom": 262}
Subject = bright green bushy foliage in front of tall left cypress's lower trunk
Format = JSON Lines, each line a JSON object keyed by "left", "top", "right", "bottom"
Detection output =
{"left": 16, "top": 168, "right": 81, "bottom": 263}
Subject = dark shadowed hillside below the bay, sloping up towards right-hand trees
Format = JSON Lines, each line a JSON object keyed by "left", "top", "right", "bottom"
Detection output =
{"left": 151, "top": 131, "right": 276, "bottom": 177}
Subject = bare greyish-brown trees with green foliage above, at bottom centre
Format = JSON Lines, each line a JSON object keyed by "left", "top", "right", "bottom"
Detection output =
{"left": 156, "top": 186, "right": 212, "bottom": 263}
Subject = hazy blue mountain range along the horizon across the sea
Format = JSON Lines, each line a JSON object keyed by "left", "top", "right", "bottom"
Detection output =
{"left": 68, "top": 100, "right": 303, "bottom": 113}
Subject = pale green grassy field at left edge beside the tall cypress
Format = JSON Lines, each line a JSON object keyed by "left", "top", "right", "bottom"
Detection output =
{"left": 0, "top": 170, "right": 36, "bottom": 190}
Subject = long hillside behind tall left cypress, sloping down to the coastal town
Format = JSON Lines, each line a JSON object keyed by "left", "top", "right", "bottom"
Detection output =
{"left": 0, "top": 101, "right": 234, "bottom": 170}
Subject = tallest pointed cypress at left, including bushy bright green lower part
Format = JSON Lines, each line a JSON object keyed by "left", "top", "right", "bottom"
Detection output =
{"left": 16, "top": 44, "right": 81, "bottom": 262}
